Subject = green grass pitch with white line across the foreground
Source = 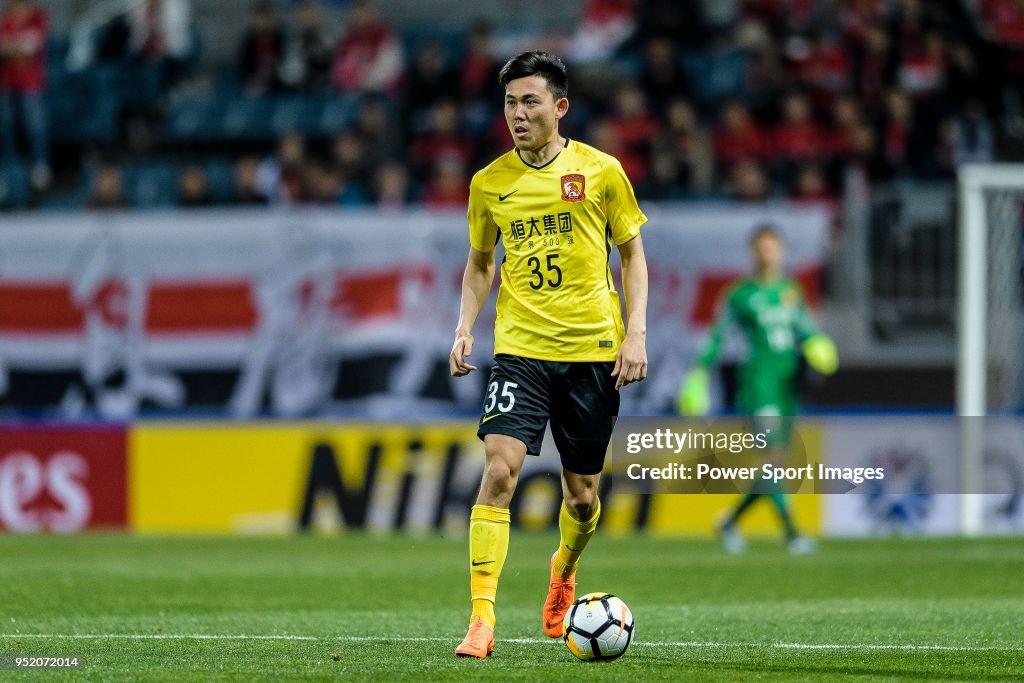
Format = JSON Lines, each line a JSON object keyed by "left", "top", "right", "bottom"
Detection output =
{"left": 0, "top": 531, "right": 1024, "bottom": 681}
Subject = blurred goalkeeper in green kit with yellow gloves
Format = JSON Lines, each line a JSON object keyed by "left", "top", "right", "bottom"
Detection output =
{"left": 677, "top": 224, "right": 839, "bottom": 554}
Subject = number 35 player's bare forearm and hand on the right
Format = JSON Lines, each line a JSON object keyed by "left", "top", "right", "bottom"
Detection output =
{"left": 611, "top": 234, "right": 647, "bottom": 389}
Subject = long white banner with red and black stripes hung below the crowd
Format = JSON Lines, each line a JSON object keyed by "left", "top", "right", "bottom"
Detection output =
{"left": 0, "top": 204, "right": 829, "bottom": 419}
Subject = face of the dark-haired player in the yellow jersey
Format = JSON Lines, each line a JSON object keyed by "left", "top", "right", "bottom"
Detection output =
{"left": 505, "top": 76, "right": 569, "bottom": 152}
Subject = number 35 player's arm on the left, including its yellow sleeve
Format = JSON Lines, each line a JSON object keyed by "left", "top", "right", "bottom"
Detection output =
{"left": 449, "top": 171, "right": 499, "bottom": 377}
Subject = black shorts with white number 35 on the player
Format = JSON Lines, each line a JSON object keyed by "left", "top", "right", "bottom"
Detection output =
{"left": 476, "top": 353, "right": 618, "bottom": 474}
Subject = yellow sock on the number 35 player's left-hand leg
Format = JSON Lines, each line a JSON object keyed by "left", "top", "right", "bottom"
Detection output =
{"left": 469, "top": 505, "right": 511, "bottom": 628}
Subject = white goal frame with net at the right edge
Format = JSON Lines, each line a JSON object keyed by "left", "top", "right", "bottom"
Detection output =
{"left": 956, "top": 164, "right": 1024, "bottom": 536}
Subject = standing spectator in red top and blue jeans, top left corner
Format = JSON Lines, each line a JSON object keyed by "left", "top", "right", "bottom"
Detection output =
{"left": 0, "top": 0, "right": 50, "bottom": 191}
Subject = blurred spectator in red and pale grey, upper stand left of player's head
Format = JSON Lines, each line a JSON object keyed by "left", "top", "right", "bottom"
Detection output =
{"left": 331, "top": 0, "right": 406, "bottom": 94}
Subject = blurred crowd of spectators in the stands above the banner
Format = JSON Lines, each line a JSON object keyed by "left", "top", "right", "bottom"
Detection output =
{"left": 0, "top": 0, "right": 1024, "bottom": 208}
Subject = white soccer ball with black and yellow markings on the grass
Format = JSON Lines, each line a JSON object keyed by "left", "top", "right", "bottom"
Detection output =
{"left": 562, "top": 593, "right": 633, "bottom": 661}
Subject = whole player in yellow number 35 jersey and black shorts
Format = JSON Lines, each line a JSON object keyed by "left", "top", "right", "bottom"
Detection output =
{"left": 450, "top": 51, "right": 647, "bottom": 657}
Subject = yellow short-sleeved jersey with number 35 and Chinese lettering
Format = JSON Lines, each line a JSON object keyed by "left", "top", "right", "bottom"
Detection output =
{"left": 469, "top": 140, "right": 647, "bottom": 361}
